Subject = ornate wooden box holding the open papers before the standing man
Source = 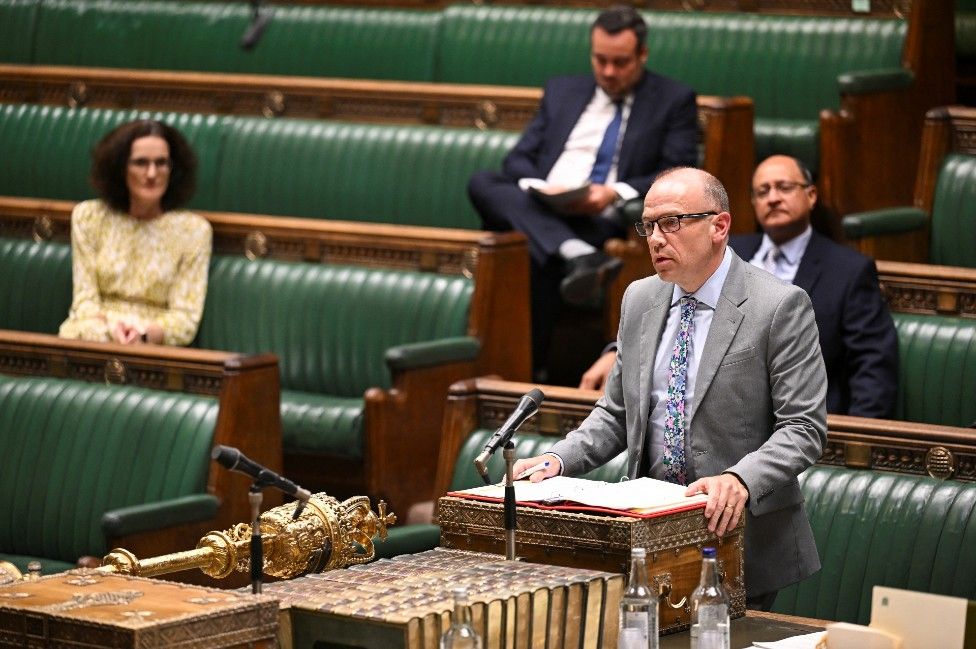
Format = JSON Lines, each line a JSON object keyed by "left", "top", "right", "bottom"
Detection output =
{"left": 437, "top": 496, "right": 746, "bottom": 634}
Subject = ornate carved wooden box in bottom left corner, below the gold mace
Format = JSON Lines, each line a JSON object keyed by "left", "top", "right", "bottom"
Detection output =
{"left": 0, "top": 569, "right": 278, "bottom": 649}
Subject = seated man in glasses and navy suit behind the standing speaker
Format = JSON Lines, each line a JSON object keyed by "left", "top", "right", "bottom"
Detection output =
{"left": 580, "top": 155, "right": 898, "bottom": 418}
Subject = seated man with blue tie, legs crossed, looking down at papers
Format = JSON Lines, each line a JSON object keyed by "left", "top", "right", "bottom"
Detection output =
{"left": 468, "top": 7, "right": 698, "bottom": 378}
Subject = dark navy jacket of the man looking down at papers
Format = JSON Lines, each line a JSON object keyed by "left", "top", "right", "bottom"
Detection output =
{"left": 502, "top": 72, "right": 698, "bottom": 195}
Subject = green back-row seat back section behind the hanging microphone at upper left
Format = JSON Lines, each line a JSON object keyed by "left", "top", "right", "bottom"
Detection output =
{"left": 31, "top": 0, "right": 439, "bottom": 81}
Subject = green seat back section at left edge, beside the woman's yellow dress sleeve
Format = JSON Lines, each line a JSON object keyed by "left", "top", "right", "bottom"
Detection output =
{"left": 0, "top": 239, "right": 71, "bottom": 334}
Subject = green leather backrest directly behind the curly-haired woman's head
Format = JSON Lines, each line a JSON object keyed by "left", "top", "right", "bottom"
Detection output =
{"left": 0, "top": 104, "right": 517, "bottom": 230}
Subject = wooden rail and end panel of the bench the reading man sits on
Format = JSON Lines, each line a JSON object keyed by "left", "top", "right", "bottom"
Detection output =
{"left": 0, "top": 65, "right": 755, "bottom": 232}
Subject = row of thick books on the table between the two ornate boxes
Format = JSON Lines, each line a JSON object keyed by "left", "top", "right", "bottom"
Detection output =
{"left": 264, "top": 548, "right": 624, "bottom": 649}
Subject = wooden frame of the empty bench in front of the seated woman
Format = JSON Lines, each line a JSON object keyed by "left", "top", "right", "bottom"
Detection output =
{"left": 0, "top": 329, "right": 283, "bottom": 572}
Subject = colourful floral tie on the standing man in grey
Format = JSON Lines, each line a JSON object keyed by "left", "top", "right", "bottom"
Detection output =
{"left": 663, "top": 296, "right": 698, "bottom": 484}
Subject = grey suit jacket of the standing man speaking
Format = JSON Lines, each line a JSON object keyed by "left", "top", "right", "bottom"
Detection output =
{"left": 551, "top": 254, "right": 827, "bottom": 596}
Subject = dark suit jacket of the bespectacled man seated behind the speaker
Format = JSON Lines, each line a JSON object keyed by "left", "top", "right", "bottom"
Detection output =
{"left": 729, "top": 232, "right": 898, "bottom": 417}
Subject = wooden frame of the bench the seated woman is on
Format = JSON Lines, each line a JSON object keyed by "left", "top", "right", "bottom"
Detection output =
{"left": 0, "top": 197, "right": 531, "bottom": 511}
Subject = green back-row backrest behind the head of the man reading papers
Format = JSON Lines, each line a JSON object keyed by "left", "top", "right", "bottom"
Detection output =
{"left": 437, "top": 5, "right": 906, "bottom": 120}
